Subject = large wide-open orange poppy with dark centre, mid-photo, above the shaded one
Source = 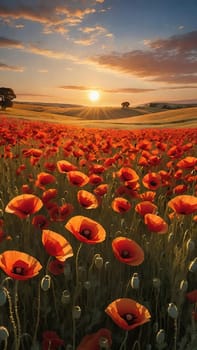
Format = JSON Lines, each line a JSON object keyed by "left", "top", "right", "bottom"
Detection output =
{"left": 65, "top": 215, "right": 106, "bottom": 244}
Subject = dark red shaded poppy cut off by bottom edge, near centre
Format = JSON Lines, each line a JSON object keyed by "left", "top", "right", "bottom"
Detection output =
{"left": 77, "top": 328, "right": 112, "bottom": 350}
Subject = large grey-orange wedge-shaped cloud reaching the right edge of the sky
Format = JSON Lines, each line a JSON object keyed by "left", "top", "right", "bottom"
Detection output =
{"left": 91, "top": 31, "right": 197, "bottom": 84}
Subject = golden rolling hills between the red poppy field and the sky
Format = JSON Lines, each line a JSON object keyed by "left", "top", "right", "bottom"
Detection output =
{"left": 0, "top": 103, "right": 197, "bottom": 129}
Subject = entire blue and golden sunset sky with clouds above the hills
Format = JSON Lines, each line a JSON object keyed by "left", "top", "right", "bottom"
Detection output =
{"left": 0, "top": 0, "right": 197, "bottom": 106}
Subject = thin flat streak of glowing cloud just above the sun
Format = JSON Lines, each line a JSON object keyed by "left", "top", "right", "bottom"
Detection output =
{"left": 59, "top": 85, "right": 155, "bottom": 94}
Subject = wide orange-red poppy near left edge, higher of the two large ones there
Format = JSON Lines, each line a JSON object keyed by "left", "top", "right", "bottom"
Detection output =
{"left": 5, "top": 194, "right": 43, "bottom": 219}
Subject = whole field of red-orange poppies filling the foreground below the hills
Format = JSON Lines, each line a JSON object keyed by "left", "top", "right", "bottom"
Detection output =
{"left": 0, "top": 117, "right": 197, "bottom": 350}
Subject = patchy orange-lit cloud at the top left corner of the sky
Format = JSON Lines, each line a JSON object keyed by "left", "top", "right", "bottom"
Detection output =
{"left": 0, "top": 0, "right": 102, "bottom": 32}
